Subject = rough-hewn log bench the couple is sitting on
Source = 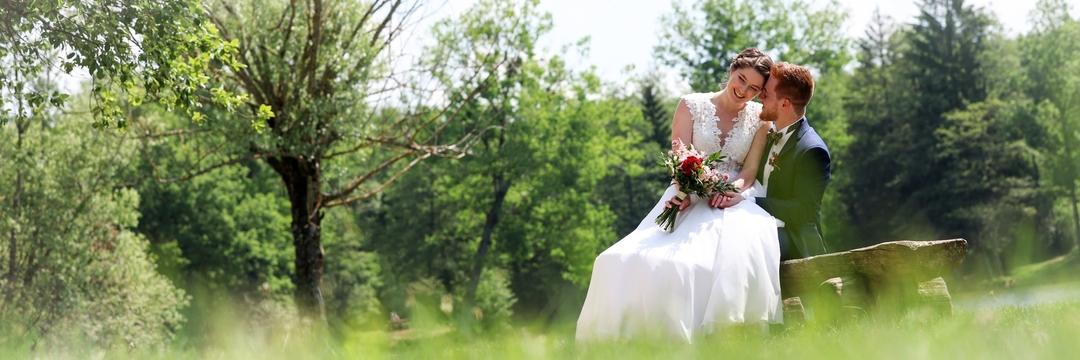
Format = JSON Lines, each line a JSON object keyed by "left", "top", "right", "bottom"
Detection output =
{"left": 780, "top": 239, "right": 968, "bottom": 322}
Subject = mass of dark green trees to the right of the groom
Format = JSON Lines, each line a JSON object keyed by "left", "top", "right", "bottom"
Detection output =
{"left": 841, "top": 1, "right": 1080, "bottom": 276}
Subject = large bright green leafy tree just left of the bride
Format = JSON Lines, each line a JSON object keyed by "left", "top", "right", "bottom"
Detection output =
{"left": 357, "top": 1, "right": 648, "bottom": 321}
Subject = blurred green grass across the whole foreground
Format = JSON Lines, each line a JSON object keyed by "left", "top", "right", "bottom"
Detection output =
{"left": 8, "top": 288, "right": 1080, "bottom": 359}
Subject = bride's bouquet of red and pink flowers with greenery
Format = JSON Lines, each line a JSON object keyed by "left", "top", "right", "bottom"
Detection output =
{"left": 657, "top": 138, "right": 739, "bottom": 232}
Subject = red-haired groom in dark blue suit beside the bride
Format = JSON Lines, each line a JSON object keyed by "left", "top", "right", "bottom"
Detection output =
{"left": 720, "top": 63, "right": 831, "bottom": 259}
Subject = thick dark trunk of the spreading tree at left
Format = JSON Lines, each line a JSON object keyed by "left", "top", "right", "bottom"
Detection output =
{"left": 268, "top": 157, "right": 326, "bottom": 322}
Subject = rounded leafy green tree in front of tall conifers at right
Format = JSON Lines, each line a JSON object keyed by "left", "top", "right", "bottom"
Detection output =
{"left": 927, "top": 97, "right": 1044, "bottom": 272}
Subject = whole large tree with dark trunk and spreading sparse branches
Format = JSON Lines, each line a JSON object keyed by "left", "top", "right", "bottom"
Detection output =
{"left": 133, "top": 0, "right": 508, "bottom": 318}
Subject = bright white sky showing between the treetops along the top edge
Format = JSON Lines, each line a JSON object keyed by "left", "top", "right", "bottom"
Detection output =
{"left": 409, "top": 0, "right": 1080, "bottom": 91}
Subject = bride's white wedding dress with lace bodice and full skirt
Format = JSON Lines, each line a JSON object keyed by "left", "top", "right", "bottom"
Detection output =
{"left": 577, "top": 94, "right": 783, "bottom": 342}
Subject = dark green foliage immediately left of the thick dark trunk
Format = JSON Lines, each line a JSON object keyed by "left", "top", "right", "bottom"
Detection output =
{"left": 139, "top": 164, "right": 293, "bottom": 295}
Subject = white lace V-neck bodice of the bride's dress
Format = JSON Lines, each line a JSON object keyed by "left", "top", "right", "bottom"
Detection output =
{"left": 683, "top": 93, "right": 761, "bottom": 176}
